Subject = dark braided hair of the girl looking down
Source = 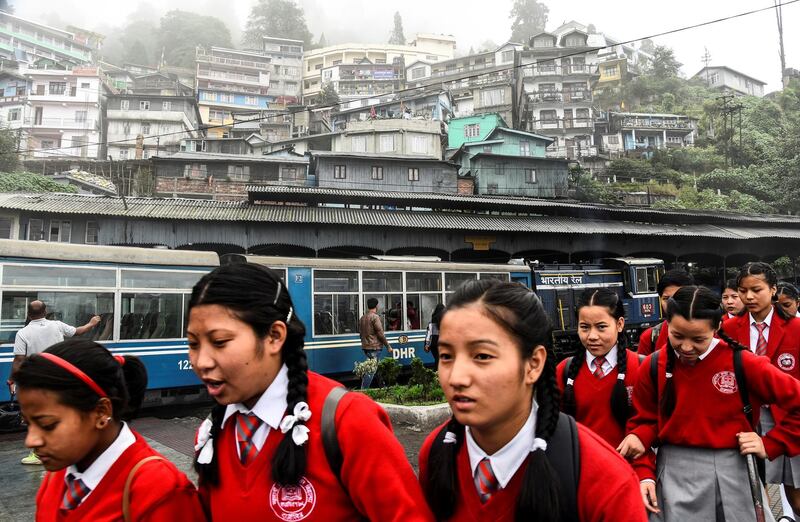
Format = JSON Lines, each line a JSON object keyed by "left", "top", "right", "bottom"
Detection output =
{"left": 659, "top": 286, "right": 746, "bottom": 418}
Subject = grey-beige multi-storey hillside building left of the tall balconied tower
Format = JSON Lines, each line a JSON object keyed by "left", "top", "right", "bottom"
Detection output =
{"left": 405, "top": 43, "right": 522, "bottom": 127}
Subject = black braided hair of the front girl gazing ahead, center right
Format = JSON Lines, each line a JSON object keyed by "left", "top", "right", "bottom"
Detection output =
{"left": 425, "top": 279, "right": 562, "bottom": 522}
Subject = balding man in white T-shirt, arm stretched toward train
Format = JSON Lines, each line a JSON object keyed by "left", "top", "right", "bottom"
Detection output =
{"left": 6, "top": 301, "right": 100, "bottom": 464}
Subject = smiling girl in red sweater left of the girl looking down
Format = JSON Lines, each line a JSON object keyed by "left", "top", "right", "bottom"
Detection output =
{"left": 557, "top": 288, "right": 639, "bottom": 448}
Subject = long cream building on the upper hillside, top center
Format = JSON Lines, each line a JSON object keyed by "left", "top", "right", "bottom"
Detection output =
{"left": 303, "top": 35, "right": 455, "bottom": 104}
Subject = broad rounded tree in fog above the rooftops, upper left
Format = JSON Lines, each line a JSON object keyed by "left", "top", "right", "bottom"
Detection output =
{"left": 158, "top": 9, "right": 232, "bottom": 69}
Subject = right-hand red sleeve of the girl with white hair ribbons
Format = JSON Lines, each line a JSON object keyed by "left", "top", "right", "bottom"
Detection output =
{"left": 336, "top": 393, "right": 433, "bottom": 522}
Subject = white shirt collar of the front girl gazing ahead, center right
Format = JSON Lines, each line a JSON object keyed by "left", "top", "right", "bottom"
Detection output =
{"left": 466, "top": 400, "right": 539, "bottom": 489}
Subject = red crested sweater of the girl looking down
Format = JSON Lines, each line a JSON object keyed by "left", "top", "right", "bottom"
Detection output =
{"left": 628, "top": 341, "right": 800, "bottom": 479}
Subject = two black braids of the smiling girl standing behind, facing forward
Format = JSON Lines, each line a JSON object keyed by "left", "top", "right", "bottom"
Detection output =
{"left": 561, "top": 288, "right": 631, "bottom": 428}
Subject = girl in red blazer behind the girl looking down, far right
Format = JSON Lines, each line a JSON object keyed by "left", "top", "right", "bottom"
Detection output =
{"left": 722, "top": 262, "right": 800, "bottom": 515}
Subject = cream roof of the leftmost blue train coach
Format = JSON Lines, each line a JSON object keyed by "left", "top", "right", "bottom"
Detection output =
{"left": 0, "top": 239, "right": 219, "bottom": 267}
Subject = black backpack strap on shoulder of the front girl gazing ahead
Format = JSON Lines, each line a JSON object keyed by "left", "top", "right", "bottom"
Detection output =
{"left": 545, "top": 413, "right": 581, "bottom": 522}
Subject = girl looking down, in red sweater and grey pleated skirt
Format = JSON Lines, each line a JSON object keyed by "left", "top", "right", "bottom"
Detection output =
{"left": 626, "top": 286, "right": 800, "bottom": 522}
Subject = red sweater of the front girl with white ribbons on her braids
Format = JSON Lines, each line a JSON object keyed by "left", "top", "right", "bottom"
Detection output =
{"left": 200, "top": 372, "right": 433, "bottom": 522}
